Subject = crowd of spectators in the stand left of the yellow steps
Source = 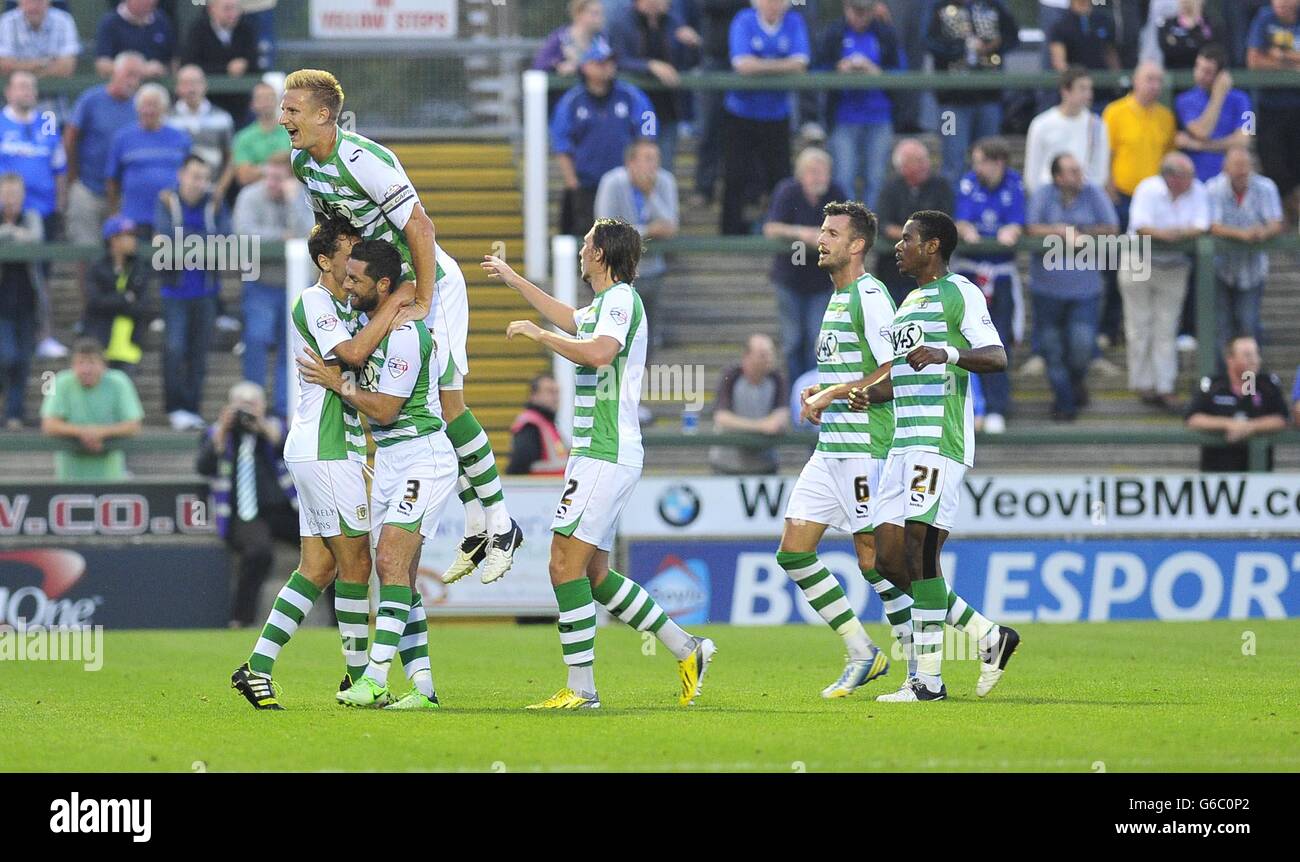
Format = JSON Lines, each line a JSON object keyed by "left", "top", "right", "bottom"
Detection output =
{"left": 0, "top": 0, "right": 289, "bottom": 444}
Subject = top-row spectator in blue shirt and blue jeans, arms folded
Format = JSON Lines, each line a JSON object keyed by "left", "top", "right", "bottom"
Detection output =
{"left": 816, "top": 0, "right": 904, "bottom": 209}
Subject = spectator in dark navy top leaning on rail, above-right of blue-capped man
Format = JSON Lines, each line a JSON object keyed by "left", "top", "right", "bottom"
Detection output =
{"left": 610, "top": 0, "right": 698, "bottom": 173}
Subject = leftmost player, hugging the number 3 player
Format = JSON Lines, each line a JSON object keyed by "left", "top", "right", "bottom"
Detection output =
{"left": 230, "top": 218, "right": 371, "bottom": 710}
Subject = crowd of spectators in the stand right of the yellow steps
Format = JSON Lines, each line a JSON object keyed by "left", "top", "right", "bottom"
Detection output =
{"left": 536, "top": 0, "right": 1300, "bottom": 442}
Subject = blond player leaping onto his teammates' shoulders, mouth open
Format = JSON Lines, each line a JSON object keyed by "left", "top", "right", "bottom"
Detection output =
{"left": 280, "top": 69, "right": 524, "bottom": 584}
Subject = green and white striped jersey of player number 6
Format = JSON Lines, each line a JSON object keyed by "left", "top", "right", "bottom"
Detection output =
{"left": 816, "top": 273, "right": 894, "bottom": 458}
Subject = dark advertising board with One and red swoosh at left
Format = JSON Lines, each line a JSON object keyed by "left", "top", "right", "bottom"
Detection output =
{"left": 0, "top": 541, "right": 230, "bottom": 629}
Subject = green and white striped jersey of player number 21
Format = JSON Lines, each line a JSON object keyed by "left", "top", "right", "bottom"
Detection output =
{"left": 889, "top": 273, "right": 1002, "bottom": 467}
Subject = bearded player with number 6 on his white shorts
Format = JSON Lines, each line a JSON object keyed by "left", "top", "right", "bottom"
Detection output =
{"left": 776, "top": 202, "right": 894, "bottom": 697}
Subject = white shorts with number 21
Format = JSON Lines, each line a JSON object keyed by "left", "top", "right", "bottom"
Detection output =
{"left": 871, "top": 449, "right": 966, "bottom": 530}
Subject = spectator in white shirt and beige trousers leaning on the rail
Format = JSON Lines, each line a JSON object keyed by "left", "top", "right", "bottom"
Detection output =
{"left": 1119, "top": 152, "right": 1210, "bottom": 411}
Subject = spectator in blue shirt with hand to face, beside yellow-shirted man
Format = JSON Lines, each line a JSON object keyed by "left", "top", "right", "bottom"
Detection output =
{"left": 1174, "top": 44, "right": 1252, "bottom": 182}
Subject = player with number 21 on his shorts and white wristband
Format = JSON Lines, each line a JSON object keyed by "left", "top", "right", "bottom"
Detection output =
{"left": 849, "top": 209, "right": 1021, "bottom": 702}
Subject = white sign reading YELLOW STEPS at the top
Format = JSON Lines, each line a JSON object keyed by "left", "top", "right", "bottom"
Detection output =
{"left": 311, "top": 0, "right": 456, "bottom": 39}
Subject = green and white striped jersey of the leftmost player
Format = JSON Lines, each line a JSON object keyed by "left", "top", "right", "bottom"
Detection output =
{"left": 285, "top": 282, "right": 365, "bottom": 462}
